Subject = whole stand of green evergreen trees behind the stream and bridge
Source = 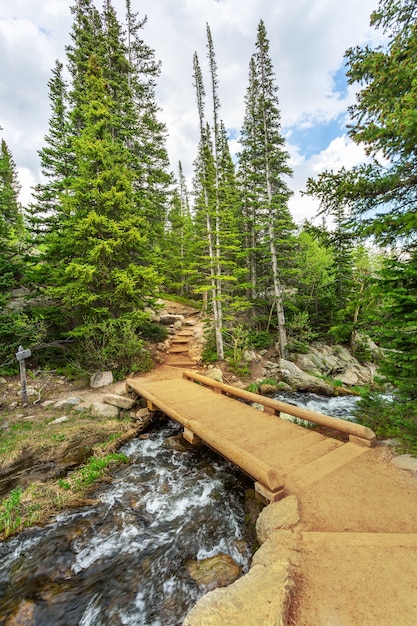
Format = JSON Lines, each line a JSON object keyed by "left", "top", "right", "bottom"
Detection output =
{"left": 0, "top": 0, "right": 417, "bottom": 452}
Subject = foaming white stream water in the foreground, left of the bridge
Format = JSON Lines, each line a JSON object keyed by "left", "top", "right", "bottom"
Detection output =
{"left": 0, "top": 422, "right": 250, "bottom": 626}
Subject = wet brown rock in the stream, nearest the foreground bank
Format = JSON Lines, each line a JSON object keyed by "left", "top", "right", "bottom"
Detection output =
{"left": 185, "top": 554, "right": 241, "bottom": 590}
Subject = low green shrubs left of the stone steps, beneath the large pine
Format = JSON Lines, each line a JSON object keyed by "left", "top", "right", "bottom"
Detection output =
{"left": 70, "top": 316, "right": 153, "bottom": 376}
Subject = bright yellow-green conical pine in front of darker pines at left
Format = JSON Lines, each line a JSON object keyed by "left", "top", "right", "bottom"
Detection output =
{"left": 48, "top": 57, "right": 156, "bottom": 323}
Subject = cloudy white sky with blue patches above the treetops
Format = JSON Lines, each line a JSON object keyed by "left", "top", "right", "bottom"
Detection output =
{"left": 0, "top": 0, "right": 379, "bottom": 223}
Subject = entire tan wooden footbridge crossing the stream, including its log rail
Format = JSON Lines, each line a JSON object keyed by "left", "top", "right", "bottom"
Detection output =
{"left": 127, "top": 371, "right": 376, "bottom": 502}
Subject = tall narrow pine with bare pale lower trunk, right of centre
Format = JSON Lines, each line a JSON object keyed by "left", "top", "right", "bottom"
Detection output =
{"left": 239, "top": 20, "right": 295, "bottom": 357}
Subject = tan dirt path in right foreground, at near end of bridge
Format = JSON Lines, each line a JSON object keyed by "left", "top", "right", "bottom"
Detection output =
{"left": 290, "top": 447, "right": 417, "bottom": 626}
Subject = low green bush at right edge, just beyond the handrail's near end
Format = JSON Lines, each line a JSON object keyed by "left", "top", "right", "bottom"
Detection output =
{"left": 355, "top": 392, "right": 417, "bottom": 456}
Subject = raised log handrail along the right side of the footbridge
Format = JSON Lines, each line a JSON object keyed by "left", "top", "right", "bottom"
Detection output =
{"left": 183, "top": 370, "right": 376, "bottom": 442}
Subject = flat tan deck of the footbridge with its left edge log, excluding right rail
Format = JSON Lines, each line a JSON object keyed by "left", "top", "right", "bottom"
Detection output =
{"left": 127, "top": 378, "right": 368, "bottom": 501}
